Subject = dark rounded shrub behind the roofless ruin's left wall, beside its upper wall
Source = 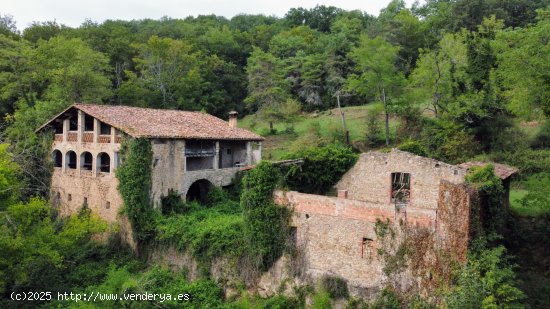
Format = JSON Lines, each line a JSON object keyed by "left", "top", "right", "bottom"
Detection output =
{"left": 285, "top": 144, "right": 358, "bottom": 194}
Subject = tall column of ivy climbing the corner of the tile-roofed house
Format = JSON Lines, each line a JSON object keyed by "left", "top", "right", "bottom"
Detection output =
{"left": 116, "top": 138, "right": 155, "bottom": 243}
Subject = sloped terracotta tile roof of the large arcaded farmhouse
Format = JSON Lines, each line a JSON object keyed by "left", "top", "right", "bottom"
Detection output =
{"left": 38, "top": 103, "right": 263, "bottom": 141}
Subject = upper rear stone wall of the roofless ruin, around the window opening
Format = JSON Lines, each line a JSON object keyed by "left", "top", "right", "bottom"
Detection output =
{"left": 336, "top": 149, "right": 466, "bottom": 209}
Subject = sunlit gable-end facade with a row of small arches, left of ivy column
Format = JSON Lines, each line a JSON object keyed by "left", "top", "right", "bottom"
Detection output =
{"left": 51, "top": 112, "right": 122, "bottom": 223}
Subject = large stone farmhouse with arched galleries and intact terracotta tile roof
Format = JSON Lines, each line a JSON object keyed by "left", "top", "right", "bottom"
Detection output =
{"left": 39, "top": 104, "right": 263, "bottom": 223}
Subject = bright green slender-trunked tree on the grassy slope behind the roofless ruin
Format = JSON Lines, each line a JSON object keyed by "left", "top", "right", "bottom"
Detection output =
{"left": 347, "top": 35, "right": 404, "bottom": 146}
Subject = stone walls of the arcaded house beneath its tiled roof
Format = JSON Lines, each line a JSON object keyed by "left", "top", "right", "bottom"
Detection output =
{"left": 43, "top": 105, "right": 261, "bottom": 227}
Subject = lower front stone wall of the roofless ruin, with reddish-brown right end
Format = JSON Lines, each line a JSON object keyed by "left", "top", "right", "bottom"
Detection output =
{"left": 274, "top": 181, "right": 475, "bottom": 298}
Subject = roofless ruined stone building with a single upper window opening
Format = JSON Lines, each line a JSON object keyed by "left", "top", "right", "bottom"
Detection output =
{"left": 275, "top": 149, "right": 516, "bottom": 298}
